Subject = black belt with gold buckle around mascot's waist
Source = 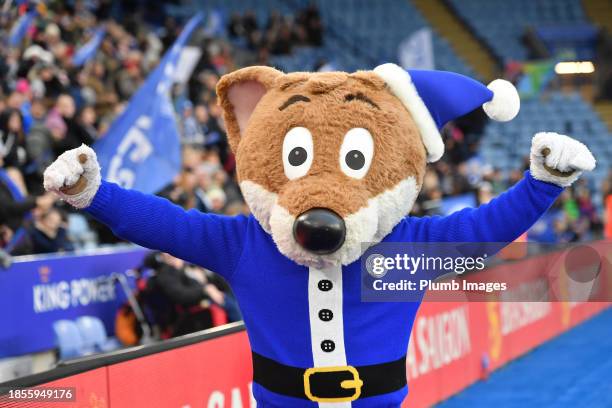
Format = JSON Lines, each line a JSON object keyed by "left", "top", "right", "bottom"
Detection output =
{"left": 253, "top": 352, "right": 406, "bottom": 402}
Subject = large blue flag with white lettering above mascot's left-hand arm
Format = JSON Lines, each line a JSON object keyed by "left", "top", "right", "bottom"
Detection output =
{"left": 93, "top": 13, "right": 203, "bottom": 193}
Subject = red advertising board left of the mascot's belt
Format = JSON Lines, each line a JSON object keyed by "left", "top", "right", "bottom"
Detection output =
{"left": 108, "top": 331, "right": 254, "bottom": 408}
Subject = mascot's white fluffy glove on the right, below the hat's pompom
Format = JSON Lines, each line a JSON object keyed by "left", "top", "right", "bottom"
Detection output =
{"left": 530, "top": 132, "right": 595, "bottom": 187}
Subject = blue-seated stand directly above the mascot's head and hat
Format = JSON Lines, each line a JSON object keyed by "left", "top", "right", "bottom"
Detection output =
{"left": 198, "top": 0, "right": 478, "bottom": 77}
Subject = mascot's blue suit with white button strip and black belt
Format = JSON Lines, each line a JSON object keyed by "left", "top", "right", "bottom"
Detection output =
{"left": 87, "top": 171, "right": 562, "bottom": 407}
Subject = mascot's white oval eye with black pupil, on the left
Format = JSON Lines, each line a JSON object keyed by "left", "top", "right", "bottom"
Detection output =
{"left": 283, "top": 127, "right": 313, "bottom": 180}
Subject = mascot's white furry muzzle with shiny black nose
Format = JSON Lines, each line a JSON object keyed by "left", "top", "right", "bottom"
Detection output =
{"left": 240, "top": 176, "right": 419, "bottom": 268}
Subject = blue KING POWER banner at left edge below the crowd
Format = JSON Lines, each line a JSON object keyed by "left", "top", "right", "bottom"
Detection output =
{"left": 0, "top": 247, "right": 146, "bottom": 358}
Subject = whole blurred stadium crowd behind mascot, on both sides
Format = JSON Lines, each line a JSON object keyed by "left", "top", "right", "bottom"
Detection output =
{"left": 0, "top": 1, "right": 612, "bottom": 264}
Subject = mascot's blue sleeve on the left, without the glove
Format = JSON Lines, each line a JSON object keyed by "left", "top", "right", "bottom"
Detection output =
{"left": 86, "top": 181, "right": 248, "bottom": 278}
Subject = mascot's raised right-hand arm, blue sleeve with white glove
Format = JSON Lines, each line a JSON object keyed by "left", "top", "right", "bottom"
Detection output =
{"left": 406, "top": 133, "right": 595, "bottom": 242}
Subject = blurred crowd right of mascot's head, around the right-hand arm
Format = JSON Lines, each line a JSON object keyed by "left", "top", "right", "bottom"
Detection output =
{"left": 413, "top": 120, "right": 612, "bottom": 243}
